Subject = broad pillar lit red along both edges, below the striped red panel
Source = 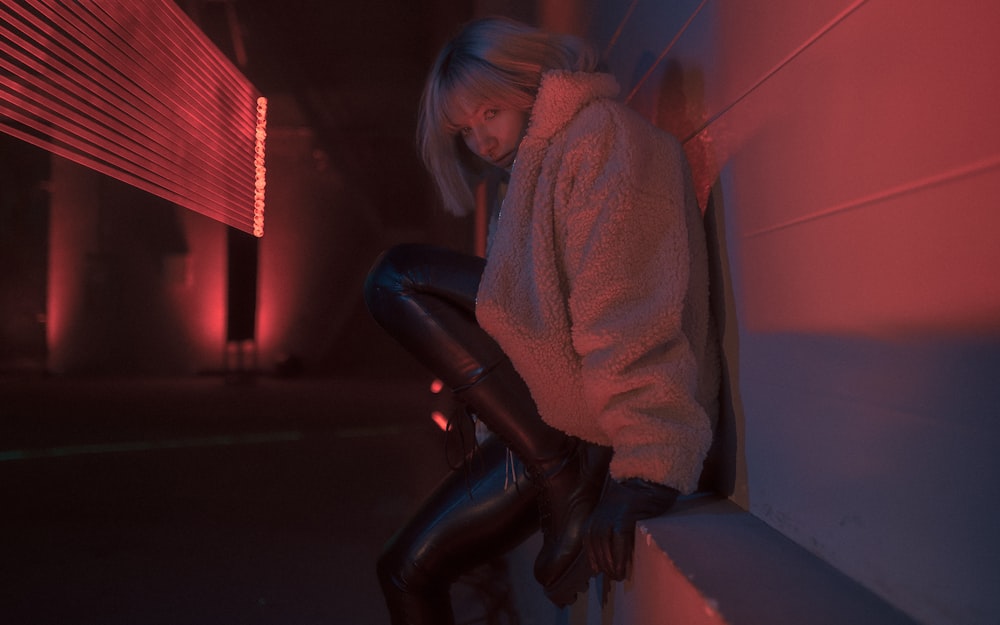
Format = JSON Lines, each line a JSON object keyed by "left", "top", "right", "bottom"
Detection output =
{"left": 47, "top": 157, "right": 226, "bottom": 375}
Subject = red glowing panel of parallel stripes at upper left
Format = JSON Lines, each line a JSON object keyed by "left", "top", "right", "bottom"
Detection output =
{"left": 0, "top": 0, "right": 266, "bottom": 236}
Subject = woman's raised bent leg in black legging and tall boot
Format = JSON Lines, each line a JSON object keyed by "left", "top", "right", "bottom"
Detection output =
{"left": 365, "top": 245, "right": 611, "bottom": 608}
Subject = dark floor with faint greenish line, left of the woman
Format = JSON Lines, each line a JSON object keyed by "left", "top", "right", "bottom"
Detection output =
{"left": 0, "top": 377, "right": 528, "bottom": 625}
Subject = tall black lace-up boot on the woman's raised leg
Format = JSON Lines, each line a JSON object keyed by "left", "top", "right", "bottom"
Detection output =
{"left": 455, "top": 359, "right": 611, "bottom": 606}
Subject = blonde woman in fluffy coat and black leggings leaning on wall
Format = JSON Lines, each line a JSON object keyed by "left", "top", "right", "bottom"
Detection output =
{"left": 365, "top": 18, "right": 719, "bottom": 623}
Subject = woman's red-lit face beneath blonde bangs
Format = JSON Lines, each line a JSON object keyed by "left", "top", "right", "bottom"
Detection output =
{"left": 453, "top": 103, "right": 528, "bottom": 171}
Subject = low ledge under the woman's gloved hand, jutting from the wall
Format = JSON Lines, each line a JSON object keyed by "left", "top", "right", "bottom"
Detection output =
{"left": 572, "top": 495, "right": 916, "bottom": 625}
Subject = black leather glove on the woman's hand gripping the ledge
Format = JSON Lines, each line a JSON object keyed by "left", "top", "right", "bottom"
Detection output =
{"left": 584, "top": 478, "right": 680, "bottom": 581}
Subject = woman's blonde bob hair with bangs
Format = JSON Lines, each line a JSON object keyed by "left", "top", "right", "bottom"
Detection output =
{"left": 417, "top": 17, "right": 597, "bottom": 215}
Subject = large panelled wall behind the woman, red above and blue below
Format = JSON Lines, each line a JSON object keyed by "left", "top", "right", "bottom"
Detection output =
{"left": 579, "top": 0, "right": 1000, "bottom": 625}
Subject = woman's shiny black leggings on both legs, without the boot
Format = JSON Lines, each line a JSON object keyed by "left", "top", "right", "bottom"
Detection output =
{"left": 365, "top": 245, "right": 539, "bottom": 625}
